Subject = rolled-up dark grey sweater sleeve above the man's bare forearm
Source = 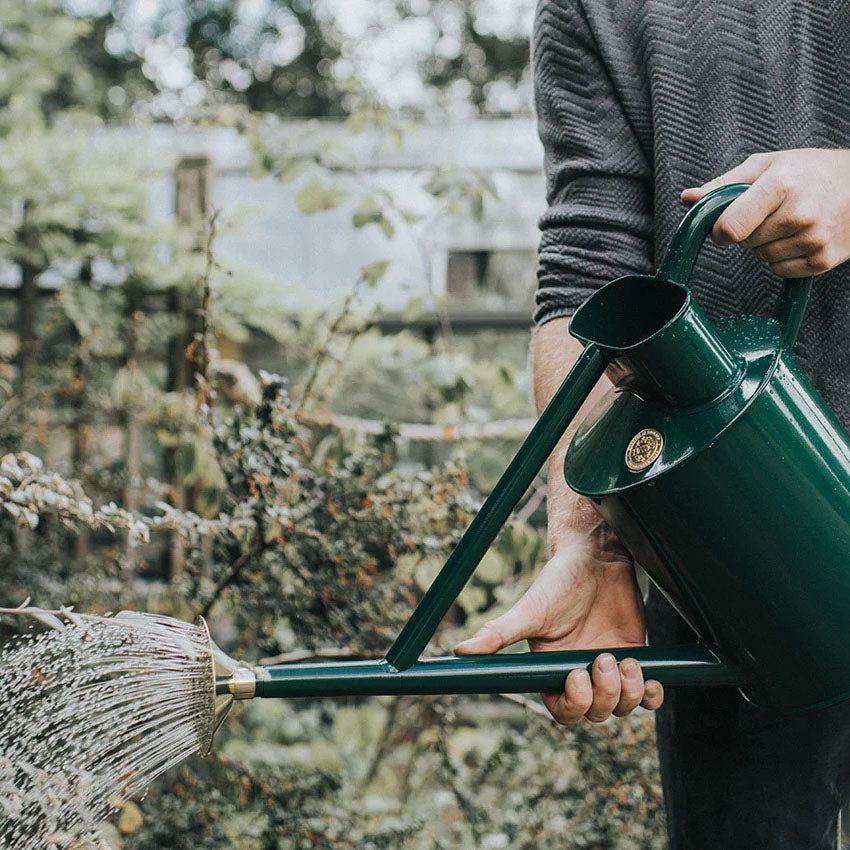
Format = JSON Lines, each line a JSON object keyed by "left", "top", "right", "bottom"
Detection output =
{"left": 532, "top": 0, "right": 653, "bottom": 325}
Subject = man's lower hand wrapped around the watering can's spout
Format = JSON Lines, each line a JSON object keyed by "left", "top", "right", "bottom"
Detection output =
{"left": 455, "top": 526, "right": 664, "bottom": 725}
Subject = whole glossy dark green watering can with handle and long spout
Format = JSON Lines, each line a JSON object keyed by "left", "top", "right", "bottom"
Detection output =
{"left": 216, "top": 184, "right": 850, "bottom": 709}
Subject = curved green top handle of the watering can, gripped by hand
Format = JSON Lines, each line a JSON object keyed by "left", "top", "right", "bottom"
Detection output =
{"left": 658, "top": 183, "right": 812, "bottom": 349}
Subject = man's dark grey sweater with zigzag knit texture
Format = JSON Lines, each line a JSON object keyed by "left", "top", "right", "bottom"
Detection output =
{"left": 533, "top": 0, "right": 850, "bottom": 427}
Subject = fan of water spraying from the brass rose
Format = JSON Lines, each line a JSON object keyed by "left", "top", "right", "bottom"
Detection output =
{"left": 0, "top": 612, "right": 214, "bottom": 850}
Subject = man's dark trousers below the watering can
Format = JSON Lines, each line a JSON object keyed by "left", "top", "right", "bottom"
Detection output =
{"left": 647, "top": 588, "right": 850, "bottom": 850}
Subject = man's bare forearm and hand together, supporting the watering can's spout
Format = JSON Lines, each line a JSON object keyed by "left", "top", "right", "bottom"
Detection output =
{"left": 474, "top": 318, "right": 664, "bottom": 724}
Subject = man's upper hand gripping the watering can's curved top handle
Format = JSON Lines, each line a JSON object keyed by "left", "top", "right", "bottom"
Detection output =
{"left": 682, "top": 148, "right": 850, "bottom": 277}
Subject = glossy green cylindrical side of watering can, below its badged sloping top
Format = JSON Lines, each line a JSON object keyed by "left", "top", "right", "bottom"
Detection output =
{"left": 600, "top": 358, "right": 850, "bottom": 708}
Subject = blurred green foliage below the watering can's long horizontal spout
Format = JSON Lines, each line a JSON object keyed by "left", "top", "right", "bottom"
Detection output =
{"left": 116, "top": 697, "right": 666, "bottom": 850}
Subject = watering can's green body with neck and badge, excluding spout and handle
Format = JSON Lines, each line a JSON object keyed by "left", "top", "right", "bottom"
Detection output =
{"left": 564, "top": 278, "right": 850, "bottom": 708}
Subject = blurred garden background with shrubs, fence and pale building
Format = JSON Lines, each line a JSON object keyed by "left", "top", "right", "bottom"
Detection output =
{"left": 0, "top": 0, "right": 664, "bottom": 850}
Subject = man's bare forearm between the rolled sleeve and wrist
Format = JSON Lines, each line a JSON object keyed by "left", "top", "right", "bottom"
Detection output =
{"left": 533, "top": 318, "right": 611, "bottom": 553}
